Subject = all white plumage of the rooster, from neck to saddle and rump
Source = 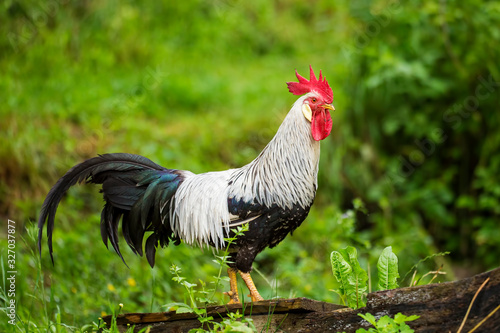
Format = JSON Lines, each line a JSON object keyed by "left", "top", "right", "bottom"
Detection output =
{"left": 170, "top": 93, "right": 320, "bottom": 248}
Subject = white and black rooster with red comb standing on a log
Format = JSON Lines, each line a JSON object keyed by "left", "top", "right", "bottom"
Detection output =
{"left": 38, "top": 67, "right": 335, "bottom": 304}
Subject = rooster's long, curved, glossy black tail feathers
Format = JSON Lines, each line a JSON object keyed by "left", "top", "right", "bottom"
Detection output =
{"left": 38, "top": 153, "right": 184, "bottom": 266}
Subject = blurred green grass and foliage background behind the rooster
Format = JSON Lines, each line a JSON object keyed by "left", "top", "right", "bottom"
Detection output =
{"left": 0, "top": 0, "right": 500, "bottom": 330}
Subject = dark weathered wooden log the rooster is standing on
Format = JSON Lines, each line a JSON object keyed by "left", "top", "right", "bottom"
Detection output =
{"left": 104, "top": 268, "right": 500, "bottom": 333}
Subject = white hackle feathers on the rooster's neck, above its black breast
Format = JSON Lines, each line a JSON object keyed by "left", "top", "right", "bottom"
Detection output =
{"left": 229, "top": 95, "right": 319, "bottom": 209}
